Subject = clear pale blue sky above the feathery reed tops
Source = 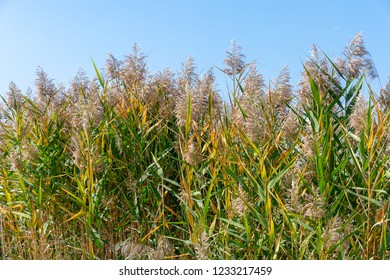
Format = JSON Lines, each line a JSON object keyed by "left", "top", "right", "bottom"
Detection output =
{"left": 0, "top": 0, "right": 390, "bottom": 97}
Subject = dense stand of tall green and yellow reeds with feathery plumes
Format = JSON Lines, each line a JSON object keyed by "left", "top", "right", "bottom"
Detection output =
{"left": 0, "top": 34, "right": 390, "bottom": 259}
